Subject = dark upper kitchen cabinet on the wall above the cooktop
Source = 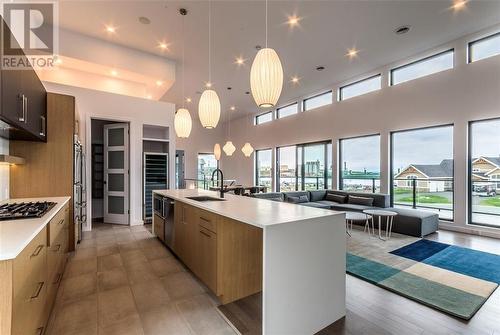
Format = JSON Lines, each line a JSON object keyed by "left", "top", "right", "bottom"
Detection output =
{"left": 0, "top": 16, "right": 47, "bottom": 141}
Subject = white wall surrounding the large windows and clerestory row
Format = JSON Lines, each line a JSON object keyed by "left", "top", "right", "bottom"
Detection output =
{"left": 218, "top": 26, "right": 500, "bottom": 239}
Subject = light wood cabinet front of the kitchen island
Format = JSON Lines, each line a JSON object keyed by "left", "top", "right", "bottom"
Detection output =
{"left": 173, "top": 201, "right": 263, "bottom": 304}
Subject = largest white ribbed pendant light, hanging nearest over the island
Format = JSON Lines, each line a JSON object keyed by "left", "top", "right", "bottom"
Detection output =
{"left": 250, "top": 0, "right": 283, "bottom": 108}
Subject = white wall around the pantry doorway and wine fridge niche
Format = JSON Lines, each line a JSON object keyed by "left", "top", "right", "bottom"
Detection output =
{"left": 44, "top": 82, "right": 175, "bottom": 230}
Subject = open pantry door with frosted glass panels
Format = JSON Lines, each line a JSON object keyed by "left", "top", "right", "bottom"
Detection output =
{"left": 104, "top": 123, "right": 129, "bottom": 225}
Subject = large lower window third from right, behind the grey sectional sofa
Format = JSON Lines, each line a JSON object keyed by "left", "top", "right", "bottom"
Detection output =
{"left": 339, "top": 135, "right": 380, "bottom": 192}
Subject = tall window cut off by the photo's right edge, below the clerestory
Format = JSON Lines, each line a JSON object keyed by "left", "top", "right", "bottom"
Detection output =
{"left": 469, "top": 119, "right": 500, "bottom": 227}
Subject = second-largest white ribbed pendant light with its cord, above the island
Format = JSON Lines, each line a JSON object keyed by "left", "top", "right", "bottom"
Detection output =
{"left": 198, "top": 0, "right": 220, "bottom": 129}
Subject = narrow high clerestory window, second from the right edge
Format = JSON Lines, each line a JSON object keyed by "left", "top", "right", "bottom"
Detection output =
{"left": 391, "top": 49, "right": 454, "bottom": 85}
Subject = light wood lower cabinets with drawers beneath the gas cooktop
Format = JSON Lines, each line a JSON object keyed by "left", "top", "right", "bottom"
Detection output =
{"left": 0, "top": 205, "right": 69, "bottom": 335}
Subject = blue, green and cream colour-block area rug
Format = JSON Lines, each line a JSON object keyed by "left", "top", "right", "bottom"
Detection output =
{"left": 347, "top": 239, "right": 500, "bottom": 320}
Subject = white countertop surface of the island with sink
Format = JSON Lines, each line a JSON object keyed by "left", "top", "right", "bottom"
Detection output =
{"left": 153, "top": 190, "right": 344, "bottom": 228}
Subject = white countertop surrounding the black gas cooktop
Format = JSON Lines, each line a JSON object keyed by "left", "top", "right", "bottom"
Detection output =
{"left": 0, "top": 197, "right": 71, "bottom": 261}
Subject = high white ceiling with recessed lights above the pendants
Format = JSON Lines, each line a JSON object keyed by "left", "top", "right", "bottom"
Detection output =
{"left": 59, "top": 0, "right": 500, "bottom": 121}
